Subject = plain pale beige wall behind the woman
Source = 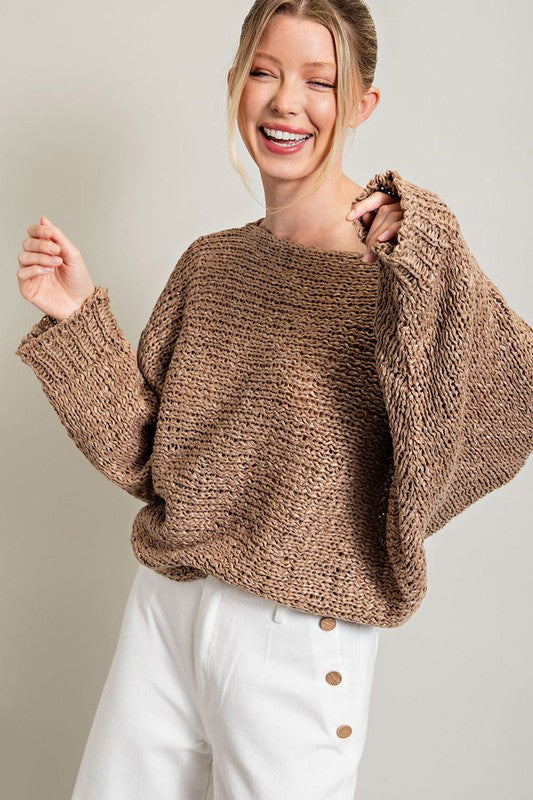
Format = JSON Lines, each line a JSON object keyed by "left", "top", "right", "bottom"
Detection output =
{"left": 0, "top": 0, "right": 533, "bottom": 800}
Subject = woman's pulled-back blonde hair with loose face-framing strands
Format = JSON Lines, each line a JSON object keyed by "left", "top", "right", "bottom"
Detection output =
{"left": 227, "top": 0, "right": 377, "bottom": 213}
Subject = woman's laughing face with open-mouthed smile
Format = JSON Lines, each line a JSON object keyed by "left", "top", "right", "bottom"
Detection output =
{"left": 238, "top": 14, "right": 350, "bottom": 180}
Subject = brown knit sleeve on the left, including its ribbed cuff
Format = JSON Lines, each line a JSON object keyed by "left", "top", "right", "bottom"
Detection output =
{"left": 15, "top": 242, "right": 195, "bottom": 502}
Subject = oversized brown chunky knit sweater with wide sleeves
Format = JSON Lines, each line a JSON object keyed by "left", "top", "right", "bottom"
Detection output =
{"left": 16, "top": 170, "right": 533, "bottom": 627}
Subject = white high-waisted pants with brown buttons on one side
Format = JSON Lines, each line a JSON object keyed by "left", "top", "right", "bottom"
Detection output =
{"left": 72, "top": 565, "right": 379, "bottom": 800}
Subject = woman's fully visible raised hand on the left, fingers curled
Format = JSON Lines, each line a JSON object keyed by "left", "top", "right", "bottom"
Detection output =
{"left": 17, "top": 217, "right": 96, "bottom": 320}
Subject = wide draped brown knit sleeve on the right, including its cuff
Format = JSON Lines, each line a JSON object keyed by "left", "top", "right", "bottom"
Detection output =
{"left": 355, "top": 170, "right": 533, "bottom": 541}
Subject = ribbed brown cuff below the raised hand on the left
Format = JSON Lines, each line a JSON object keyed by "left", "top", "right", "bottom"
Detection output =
{"left": 15, "top": 286, "right": 128, "bottom": 383}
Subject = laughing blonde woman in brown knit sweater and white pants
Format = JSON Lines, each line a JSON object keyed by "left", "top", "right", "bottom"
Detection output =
{"left": 17, "top": 0, "right": 532, "bottom": 800}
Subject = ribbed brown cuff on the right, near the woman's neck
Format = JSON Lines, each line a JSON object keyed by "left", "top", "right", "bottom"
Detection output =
{"left": 354, "top": 169, "right": 460, "bottom": 281}
